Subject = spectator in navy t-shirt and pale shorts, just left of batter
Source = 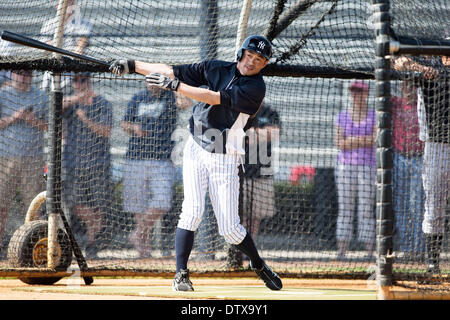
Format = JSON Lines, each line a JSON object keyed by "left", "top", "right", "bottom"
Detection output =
{"left": 121, "top": 85, "right": 183, "bottom": 257}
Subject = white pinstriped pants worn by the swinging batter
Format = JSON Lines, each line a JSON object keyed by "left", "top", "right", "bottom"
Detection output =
{"left": 178, "top": 136, "right": 247, "bottom": 244}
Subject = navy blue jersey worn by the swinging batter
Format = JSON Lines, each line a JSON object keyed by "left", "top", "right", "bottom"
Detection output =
{"left": 173, "top": 60, "right": 266, "bottom": 153}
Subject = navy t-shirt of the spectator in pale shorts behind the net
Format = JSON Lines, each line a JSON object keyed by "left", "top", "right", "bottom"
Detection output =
{"left": 123, "top": 89, "right": 177, "bottom": 160}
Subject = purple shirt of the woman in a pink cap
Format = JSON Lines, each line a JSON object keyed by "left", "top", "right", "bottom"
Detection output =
{"left": 336, "top": 109, "right": 376, "bottom": 166}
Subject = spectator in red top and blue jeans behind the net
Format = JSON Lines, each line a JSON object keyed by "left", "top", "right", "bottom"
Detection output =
{"left": 392, "top": 80, "right": 425, "bottom": 257}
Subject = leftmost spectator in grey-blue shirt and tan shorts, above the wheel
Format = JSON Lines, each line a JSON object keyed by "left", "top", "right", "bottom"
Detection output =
{"left": 0, "top": 70, "right": 48, "bottom": 252}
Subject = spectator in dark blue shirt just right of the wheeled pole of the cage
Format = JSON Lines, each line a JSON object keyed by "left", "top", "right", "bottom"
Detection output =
{"left": 62, "top": 73, "right": 112, "bottom": 257}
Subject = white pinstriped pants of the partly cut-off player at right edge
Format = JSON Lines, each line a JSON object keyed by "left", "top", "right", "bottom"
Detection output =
{"left": 422, "top": 141, "right": 450, "bottom": 234}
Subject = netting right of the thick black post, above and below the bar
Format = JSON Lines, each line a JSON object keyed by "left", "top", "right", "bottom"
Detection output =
{"left": 384, "top": 1, "right": 450, "bottom": 292}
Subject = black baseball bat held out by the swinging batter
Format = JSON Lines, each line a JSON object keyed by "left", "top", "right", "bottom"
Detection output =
{"left": 2, "top": 30, "right": 110, "bottom": 68}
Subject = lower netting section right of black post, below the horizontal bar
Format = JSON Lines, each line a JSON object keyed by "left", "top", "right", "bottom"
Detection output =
{"left": 392, "top": 71, "right": 450, "bottom": 290}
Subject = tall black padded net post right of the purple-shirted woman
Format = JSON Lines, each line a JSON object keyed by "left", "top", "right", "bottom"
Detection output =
{"left": 372, "top": 0, "right": 394, "bottom": 299}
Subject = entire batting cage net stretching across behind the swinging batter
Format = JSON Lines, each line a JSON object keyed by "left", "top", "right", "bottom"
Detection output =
{"left": 0, "top": 0, "right": 450, "bottom": 291}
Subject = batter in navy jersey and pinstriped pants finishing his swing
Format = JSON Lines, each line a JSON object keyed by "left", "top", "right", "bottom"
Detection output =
{"left": 110, "top": 35, "right": 282, "bottom": 291}
